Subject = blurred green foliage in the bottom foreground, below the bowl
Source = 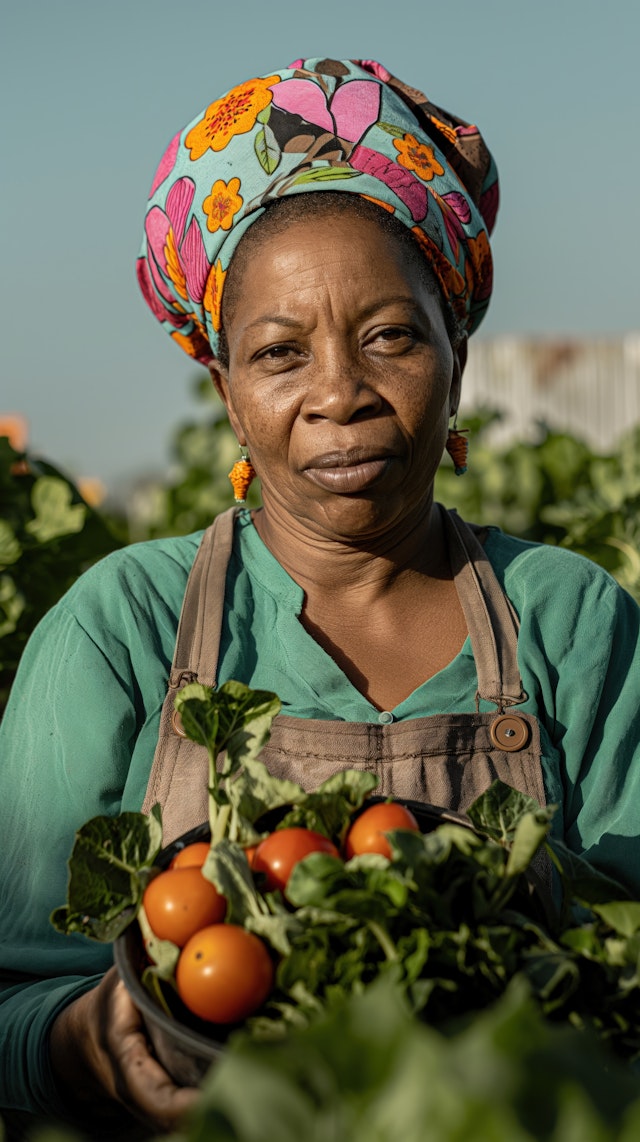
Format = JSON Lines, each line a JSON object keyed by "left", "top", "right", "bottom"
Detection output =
{"left": 181, "top": 978, "right": 640, "bottom": 1142}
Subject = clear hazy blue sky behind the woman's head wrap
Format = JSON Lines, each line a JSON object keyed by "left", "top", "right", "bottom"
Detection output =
{"left": 0, "top": 0, "right": 640, "bottom": 485}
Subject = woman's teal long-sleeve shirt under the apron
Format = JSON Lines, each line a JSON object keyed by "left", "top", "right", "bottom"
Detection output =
{"left": 0, "top": 513, "right": 640, "bottom": 1113}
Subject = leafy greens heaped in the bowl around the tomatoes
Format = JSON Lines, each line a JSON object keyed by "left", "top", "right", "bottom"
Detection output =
{"left": 51, "top": 682, "right": 640, "bottom": 1057}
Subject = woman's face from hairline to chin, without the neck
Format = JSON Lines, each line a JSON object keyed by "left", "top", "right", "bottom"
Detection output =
{"left": 214, "top": 214, "right": 462, "bottom": 539}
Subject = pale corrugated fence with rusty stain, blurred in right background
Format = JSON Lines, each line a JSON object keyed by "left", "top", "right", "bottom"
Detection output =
{"left": 458, "top": 332, "right": 640, "bottom": 451}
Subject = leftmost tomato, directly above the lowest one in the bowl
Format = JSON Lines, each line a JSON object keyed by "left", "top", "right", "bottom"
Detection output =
{"left": 143, "top": 867, "right": 226, "bottom": 948}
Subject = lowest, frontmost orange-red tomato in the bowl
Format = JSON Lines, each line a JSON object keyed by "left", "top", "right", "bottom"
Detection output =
{"left": 176, "top": 924, "right": 274, "bottom": 1023}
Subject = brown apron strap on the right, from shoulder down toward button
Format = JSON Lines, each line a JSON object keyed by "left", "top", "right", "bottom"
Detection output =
{"left": 438, "top": 505, "right": 527, "bottom": 713}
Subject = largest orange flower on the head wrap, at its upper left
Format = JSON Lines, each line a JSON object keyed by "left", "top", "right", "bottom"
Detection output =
{"left": 184, "top": 75, "right": 280, "bottom": 162}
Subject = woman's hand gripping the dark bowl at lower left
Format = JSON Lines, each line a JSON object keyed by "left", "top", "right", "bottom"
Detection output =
{"left": 50, "top": 967, "right": 198, "bottom": 1132}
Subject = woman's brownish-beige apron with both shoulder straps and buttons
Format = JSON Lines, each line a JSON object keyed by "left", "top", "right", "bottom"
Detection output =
{"left": 143, "top": 508, "right": 545, "bottom": 858}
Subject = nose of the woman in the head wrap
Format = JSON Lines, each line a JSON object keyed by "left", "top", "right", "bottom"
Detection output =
{"left": 303, "top": 353, "right": 383, "bottom": 424}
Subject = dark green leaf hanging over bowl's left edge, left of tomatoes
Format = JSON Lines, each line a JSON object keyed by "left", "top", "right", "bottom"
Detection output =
{"left": 51, "top": 806, "right": 162, "bottom": 942}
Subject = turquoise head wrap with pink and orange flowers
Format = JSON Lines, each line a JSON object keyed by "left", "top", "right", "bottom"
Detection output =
{"left": 137, "top": 59, "right": 498, "bottom": 364}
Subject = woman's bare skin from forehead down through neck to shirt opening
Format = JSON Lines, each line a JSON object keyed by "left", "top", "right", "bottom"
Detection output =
{"left": 213, "top": 215, "right": 466, "bottom": 709}
